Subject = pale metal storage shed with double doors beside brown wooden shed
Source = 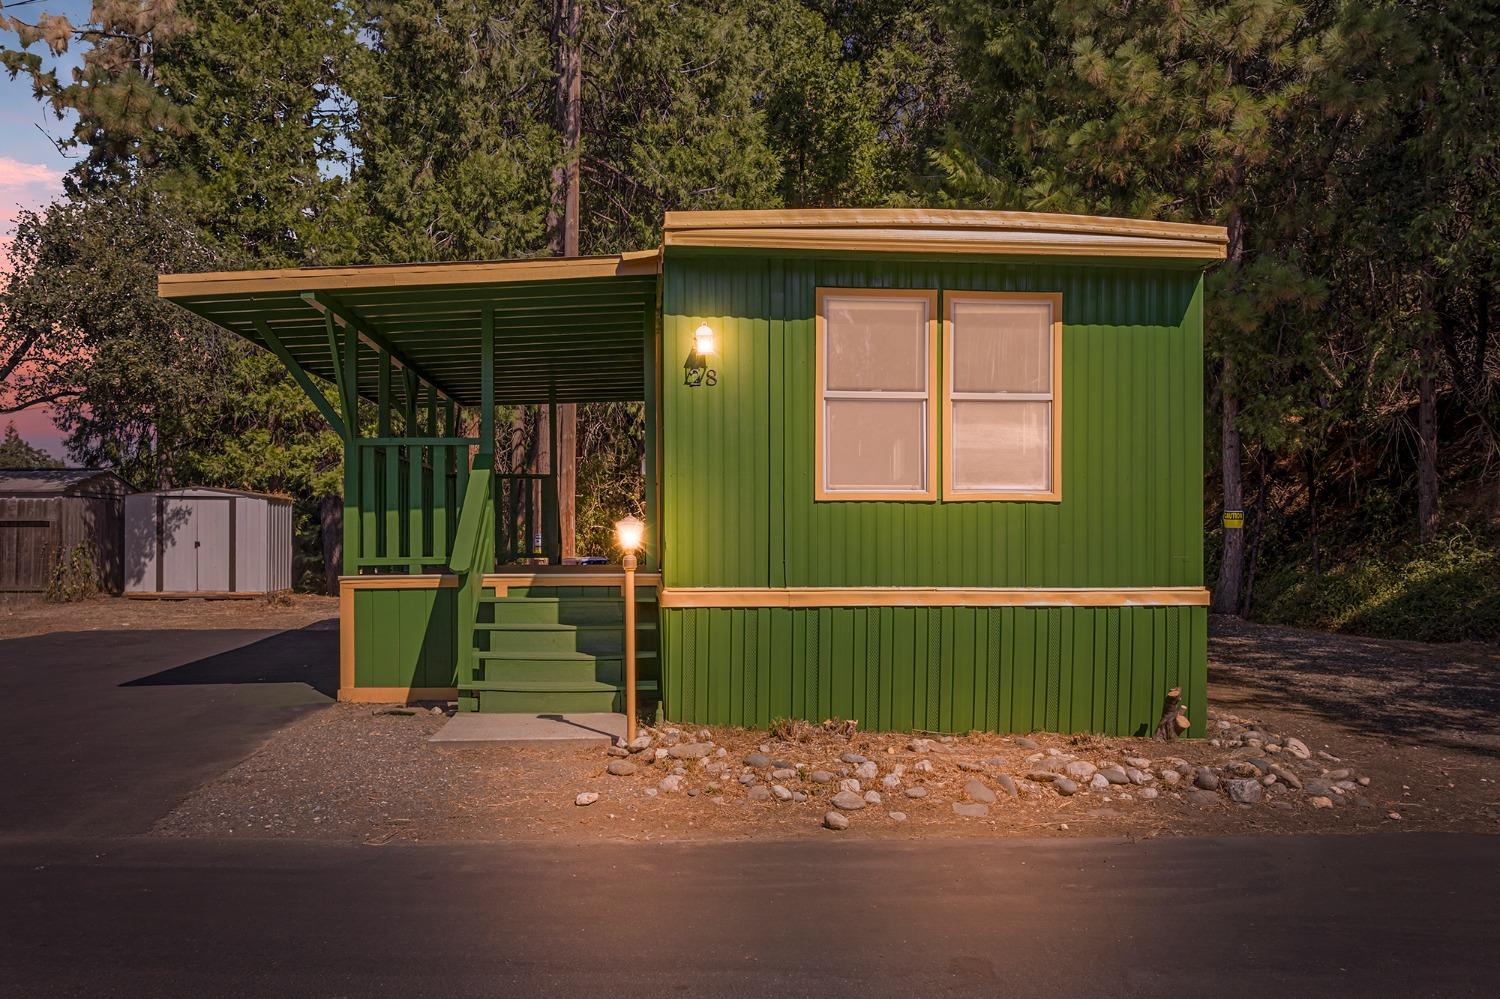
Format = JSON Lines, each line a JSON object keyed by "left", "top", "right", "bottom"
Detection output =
{"left": 125, "top": 488, "right": 291, "bottom": 596}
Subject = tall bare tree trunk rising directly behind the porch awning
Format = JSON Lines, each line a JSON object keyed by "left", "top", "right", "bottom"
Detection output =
{"left": 548, "top": 0, "right": 584, "bottom": 561}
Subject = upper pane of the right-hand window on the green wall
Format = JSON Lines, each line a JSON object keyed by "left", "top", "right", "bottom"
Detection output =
{"left": 953, "top": 302, "right": 1052, "bottom": 392}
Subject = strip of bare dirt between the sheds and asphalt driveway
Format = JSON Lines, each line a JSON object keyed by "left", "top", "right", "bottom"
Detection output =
{"left": 0, "top": 594, "right": 339, "bottom": 638}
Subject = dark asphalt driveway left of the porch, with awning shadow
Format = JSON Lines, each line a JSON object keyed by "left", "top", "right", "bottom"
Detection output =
{"left": 0, "top": 621, "right": 339, "bottom": 839}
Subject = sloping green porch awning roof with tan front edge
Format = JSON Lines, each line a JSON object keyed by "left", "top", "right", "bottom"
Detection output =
{"left": 158, "top": 251, "right": 660, "bottom": 407}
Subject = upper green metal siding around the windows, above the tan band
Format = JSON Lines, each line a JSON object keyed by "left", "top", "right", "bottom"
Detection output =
{"left": 660, "top": 252, "right": 1203, "bottom": 587}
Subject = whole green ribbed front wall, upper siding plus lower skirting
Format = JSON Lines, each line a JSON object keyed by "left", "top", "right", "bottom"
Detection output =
{"left": 660, "top": 251, "right": 1208, "bottom": 734}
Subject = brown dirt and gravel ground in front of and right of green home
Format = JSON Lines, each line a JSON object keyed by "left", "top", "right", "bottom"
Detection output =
{"left": 156, "top": 621, "right": 1500, "bottom": 843}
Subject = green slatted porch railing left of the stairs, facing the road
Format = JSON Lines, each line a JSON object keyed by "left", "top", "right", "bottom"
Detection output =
{"left": 353, "top": 437, "right": 479, "bottom": 573}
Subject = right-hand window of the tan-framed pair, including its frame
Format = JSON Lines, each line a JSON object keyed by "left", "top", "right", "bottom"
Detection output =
{"left": 944, "top": 293, "right": 1062, "bottom": 500}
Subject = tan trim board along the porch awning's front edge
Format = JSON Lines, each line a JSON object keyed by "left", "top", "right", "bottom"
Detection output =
{"left": 156, "top": 249, "right": 662, "bottom": 299}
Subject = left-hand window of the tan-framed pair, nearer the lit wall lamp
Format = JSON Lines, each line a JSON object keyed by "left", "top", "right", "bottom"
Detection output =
{"left": 816, "top": 290, "right": 938, "bottom": 500}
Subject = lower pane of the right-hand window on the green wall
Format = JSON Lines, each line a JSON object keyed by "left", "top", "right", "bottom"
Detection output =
{"left": 953, "top": 402, "right": 1052, "bottom": 492}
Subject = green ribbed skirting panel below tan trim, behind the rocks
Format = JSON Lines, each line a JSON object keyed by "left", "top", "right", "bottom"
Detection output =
{"left": 662, "top": 608, "right": 1208, "bottom": 737}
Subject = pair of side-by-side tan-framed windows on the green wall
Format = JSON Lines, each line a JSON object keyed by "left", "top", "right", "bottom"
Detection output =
{"left": 815, "top": 288, "right": 1062, "bottom": 501}
